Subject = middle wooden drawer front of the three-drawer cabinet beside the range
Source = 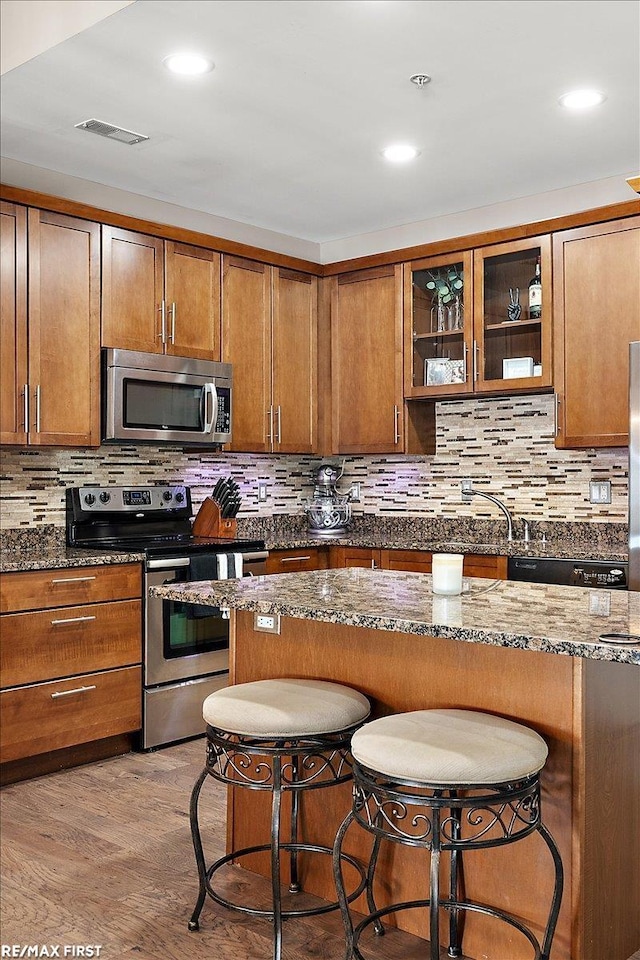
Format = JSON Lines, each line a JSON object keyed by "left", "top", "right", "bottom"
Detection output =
{"left": 0, "top": 600, "right": 142, "bottom": 687}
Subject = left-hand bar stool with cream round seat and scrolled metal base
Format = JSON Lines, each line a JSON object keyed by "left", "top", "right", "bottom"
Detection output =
{"left": 188, "top": 678, "right": 370, "bottom": 960}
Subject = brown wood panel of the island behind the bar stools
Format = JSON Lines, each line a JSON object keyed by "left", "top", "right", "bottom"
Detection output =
{"left": 229, "top": 612, "right": 640, "bottom": 960}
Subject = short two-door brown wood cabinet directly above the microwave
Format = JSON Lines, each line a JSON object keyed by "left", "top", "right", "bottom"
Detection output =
{"left": 102, "top": 225, "right": 220, "bottom": 360}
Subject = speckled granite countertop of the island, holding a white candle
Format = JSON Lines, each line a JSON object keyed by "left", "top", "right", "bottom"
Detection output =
{"left": 150, "top": 568, "right": 640, "bottom": 666}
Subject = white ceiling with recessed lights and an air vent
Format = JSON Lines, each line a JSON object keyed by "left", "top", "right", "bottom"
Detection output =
{"left": 1, "top": 0, "right": 640, "bottom": 251}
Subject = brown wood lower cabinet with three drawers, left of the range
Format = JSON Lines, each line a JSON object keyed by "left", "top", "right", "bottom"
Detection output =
{"left": 0, "top": 563, "right": 142, "bottom": 780}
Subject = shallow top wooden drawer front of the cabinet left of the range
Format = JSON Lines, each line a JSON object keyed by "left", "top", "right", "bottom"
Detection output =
{"left": 0, "top": 563, "right": 142, "bottom": 613}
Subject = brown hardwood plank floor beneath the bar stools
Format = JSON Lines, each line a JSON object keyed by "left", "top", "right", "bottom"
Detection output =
{"left": 0, "top": 740, "right": 444, "bottom": 960}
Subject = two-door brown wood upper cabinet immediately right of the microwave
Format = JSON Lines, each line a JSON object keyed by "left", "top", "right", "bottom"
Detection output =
{"left": 222, "top": 256, "right": 318, "bottom": 453}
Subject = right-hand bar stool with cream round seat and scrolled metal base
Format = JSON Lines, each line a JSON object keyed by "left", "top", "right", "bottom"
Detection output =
{"left": 334, "top": 710, "right": 563, "bottom": 960}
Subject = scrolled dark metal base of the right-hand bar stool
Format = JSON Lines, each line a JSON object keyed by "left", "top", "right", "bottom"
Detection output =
{"left": 333, "top": 761, "right": 563, "bottom": 960}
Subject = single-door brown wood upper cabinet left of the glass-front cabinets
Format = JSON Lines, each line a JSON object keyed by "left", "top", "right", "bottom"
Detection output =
{"left": 330, "top": 265, "right": 434, "bottom": 453}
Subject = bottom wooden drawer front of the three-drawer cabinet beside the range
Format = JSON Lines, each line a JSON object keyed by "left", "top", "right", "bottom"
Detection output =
{"left": 0, "top": 667, "right": 142, "bottom": 763}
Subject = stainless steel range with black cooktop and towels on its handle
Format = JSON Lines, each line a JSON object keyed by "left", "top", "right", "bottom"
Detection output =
{"left": 66, "top": 485, "right": 268, "bottom": 749}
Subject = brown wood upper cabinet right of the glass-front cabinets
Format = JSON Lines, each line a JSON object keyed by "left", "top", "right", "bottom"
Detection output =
{"left": 553, "top": 217, "right": 640, "bottom": 448}
